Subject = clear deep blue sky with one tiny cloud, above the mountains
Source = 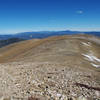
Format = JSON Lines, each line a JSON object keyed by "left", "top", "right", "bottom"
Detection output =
{"left": 0, "top": 0, "right": 100, "bottom": 34}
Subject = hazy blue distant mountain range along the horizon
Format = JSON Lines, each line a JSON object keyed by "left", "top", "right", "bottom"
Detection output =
{"left": 0, "top": 30, "right": 100, "bottom": 40}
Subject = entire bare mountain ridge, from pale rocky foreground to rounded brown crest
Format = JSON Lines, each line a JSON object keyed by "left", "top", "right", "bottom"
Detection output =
{"left": 0, "top": 34, "right": 100, "bottom": 100}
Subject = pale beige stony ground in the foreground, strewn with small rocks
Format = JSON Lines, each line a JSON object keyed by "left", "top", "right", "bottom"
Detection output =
{"left": 0, "top": 62, "right": 100, "bottom": 100}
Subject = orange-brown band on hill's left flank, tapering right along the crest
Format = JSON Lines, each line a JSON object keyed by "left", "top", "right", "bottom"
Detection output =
{"left": 0, "top": 35, "right": 99, "bottom": 63}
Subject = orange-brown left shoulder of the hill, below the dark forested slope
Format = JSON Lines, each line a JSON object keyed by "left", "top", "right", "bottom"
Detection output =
{"left": 0, "top": 39, "right": 39, "bottom": 62}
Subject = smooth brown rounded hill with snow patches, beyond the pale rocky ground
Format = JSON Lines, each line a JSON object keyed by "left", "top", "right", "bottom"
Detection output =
{"left": 0, "top": 35, "right": 100, "bottom": 67}
